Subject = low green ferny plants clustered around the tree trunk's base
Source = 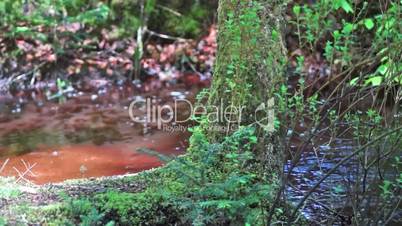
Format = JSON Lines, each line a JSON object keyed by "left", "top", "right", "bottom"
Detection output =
{"left": 81, "top": 127, "right": 281, "bottom": 225}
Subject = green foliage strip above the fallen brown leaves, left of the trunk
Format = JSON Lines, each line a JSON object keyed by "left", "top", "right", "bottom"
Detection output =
{"left": 0, "top": 0, "right": 215, "bottom": 41}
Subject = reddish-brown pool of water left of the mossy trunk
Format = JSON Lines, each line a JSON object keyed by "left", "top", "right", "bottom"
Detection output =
{"left": 0, "top": 83, "right": 192, "bottom": 184}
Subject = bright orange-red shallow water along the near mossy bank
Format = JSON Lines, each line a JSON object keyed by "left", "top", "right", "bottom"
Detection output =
{"left": 1, "top": 135, "right": 185, "bottom": 184}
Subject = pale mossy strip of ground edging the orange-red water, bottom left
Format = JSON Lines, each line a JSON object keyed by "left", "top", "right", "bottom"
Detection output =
{"left": 0, "top": 169, "right": 151, "bottom": 225}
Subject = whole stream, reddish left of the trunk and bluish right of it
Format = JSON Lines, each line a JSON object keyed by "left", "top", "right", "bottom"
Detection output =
{"left": 0, "top": 83, "right": 400, "bottom": 225}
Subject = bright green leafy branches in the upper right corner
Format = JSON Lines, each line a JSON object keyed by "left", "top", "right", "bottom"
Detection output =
{"left": 290, "top": 0, "right": 402, "bottom": 86}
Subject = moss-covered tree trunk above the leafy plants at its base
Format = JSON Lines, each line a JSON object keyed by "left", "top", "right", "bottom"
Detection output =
{"left": 205, "top": 0, "right": 286, "bottom": 176}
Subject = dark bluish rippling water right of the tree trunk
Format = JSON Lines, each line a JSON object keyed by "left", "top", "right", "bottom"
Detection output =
{"left": 285, "top": 135, "right": 402, "bottom": 225}
